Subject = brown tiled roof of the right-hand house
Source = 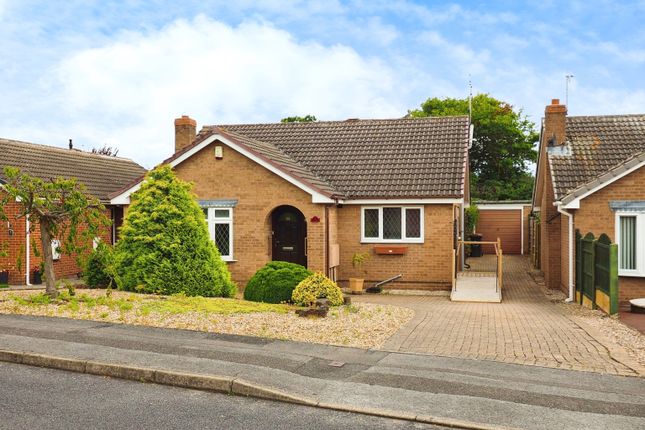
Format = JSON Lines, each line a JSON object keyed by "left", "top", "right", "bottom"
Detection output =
{"left": 549, "top": 115, "right": 645, "bottom": 200}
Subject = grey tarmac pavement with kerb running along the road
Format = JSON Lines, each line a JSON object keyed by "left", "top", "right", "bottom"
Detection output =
{"left": 0, "top": 315, "right": 645, "bottom": 429}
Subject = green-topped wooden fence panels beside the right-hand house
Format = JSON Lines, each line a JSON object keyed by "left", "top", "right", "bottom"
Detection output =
{"left": 575, "top": 230, "right": 618, "bottom": 315}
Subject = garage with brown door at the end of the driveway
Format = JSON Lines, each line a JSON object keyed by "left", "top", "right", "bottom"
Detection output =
{"left": 475, "top": 202, "right": 531, "bottom": 254}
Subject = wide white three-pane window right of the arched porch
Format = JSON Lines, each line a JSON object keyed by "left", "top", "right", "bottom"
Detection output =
{"left": 361, "top": 206, "right": 423, "bottom": 243}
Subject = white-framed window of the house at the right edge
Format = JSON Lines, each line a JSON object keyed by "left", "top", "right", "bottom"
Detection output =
{"left": 616, "top": 211, "right": 645, "bottom": 277}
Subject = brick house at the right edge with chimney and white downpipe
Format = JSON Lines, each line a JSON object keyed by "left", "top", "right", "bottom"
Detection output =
{"left": 533, "top": 99, "right": 645, "bottom": 302}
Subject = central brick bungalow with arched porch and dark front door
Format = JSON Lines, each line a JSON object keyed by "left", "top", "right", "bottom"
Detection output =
{"left": 111, "top": 116, "right": 471, "bottom": 289}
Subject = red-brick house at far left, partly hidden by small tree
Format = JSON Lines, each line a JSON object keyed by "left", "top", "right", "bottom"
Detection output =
{"left": 0, "top": 139, "right": 146, "bottom": 284}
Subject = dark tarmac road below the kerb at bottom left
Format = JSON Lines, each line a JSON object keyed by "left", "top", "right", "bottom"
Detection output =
{"left": 0, "top": 363, "right": 438, "bottom": 430}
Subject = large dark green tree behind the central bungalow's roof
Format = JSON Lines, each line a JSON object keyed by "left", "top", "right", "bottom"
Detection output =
{"left": 409, "top": 94, "right": 538, "bottom": 200}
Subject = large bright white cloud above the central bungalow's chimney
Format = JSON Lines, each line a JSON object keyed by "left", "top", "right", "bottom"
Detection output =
{"left": 42, "top": 16, "right": 410, "bottom": 166}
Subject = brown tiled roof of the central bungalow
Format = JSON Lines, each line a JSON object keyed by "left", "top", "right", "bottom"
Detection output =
{"left": 197, "top": 116, "right": 469, "bottom": 199}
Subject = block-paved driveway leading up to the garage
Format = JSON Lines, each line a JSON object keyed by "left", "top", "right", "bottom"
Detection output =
{"left": 352, "top": 256, "right": 637, "bottom": 375}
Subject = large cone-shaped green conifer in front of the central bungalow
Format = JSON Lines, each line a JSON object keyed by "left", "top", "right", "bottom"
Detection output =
{"left": 114, "top": 165, "right": 236, "bottom": 297}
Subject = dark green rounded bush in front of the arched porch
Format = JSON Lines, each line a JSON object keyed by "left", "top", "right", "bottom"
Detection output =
{"left": 244, "top": 261, "right": 311, "bottom": 303}
